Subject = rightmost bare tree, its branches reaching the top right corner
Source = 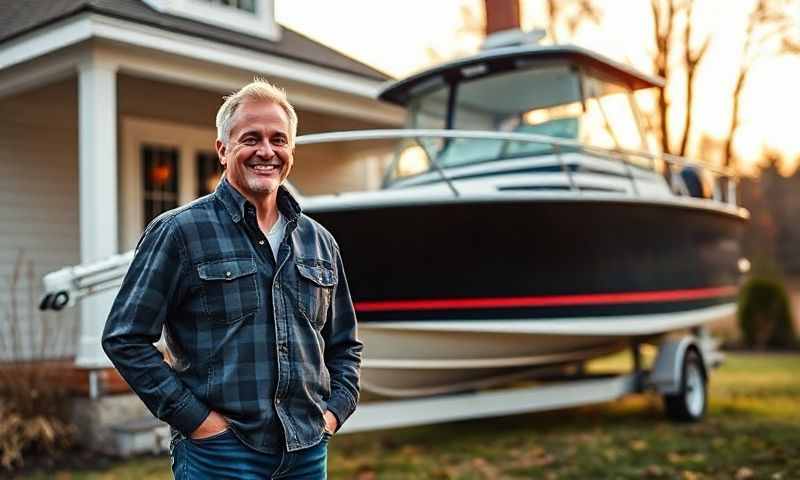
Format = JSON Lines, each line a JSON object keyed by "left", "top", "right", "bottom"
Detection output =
{"left": 724, "top": 0, "right": 800, "bottom": 167}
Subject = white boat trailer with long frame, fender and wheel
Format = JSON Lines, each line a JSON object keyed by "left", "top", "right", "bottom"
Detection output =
{"left": 339, "top": 329, "right": 723, "bottom": 434}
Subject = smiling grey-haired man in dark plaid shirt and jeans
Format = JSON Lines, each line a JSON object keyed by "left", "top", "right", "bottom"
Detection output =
{"left": 103, "top": 80, "right": 362, "bottom": 479}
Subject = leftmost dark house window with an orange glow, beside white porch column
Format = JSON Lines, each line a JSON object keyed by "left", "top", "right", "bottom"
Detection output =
{"left": 141, "top": 144, "right": 178, "bottom": 225}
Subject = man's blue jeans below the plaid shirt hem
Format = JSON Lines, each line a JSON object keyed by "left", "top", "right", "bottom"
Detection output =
{"left": 170, "top": 429, "right": 330, "bottom": 480}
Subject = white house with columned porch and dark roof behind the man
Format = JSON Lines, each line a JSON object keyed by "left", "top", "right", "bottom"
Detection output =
{"left": 0, "top": 0, "right": 402, "bottom": 386}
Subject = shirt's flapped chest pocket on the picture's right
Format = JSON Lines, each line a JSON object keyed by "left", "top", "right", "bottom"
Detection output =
{"left": 295, "top": 259, "right": 336, "bottom": 329}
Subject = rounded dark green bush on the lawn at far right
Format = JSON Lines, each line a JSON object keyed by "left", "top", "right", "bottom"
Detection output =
{"left": 737, "top": 277, "right": 797, "bottom": 349}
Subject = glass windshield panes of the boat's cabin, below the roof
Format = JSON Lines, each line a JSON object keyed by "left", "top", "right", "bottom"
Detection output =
{"left": 387, "top": 64, "right": 657, "bottom": 182}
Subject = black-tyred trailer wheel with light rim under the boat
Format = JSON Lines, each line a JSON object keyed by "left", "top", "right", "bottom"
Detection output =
{"left": 664, "top": 349, "right": 708, "bottom": 422}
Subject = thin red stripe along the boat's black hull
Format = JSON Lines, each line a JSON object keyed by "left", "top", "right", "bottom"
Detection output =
{"left": 355, "top": 286, "right": 738, "bottom": 312}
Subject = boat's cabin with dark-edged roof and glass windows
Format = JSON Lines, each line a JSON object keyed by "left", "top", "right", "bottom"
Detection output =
{"left": 380, "top": 45, "right": 664, "bottom": 182}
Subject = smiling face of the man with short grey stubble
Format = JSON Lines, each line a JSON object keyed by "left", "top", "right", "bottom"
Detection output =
{"left": 217, "top": 100, "right": 294, "bottom": 197}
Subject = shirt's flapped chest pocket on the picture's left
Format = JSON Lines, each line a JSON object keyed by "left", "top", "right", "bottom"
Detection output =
{"left": 197, "top": 257, "right": 261, "bottom": 323}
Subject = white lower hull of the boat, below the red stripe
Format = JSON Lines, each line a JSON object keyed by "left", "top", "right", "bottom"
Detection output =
{"left": 359, "top": 304, "right": 735, "bottom": 397}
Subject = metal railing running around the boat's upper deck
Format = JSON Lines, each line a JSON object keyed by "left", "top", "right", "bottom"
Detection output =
{"left": 296, "top": 129, "right": 739, "bottom": 206}
